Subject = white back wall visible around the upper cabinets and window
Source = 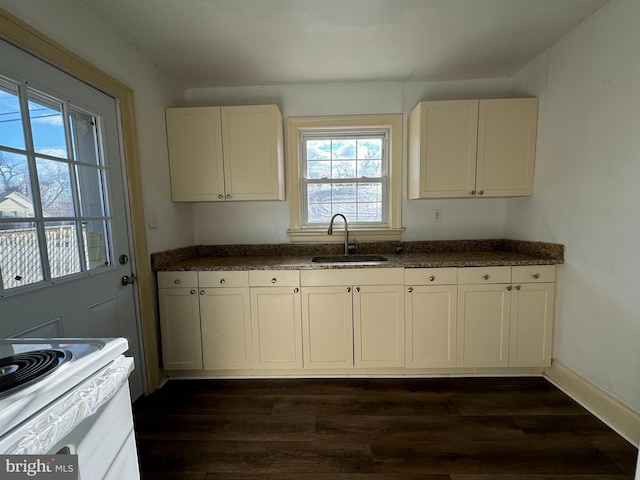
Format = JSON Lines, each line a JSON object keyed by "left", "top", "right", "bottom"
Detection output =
{"left": 185, "top": 78, "right": 511, "bottom": 244}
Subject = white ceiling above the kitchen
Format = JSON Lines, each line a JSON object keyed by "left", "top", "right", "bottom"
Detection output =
{"left": 81, "top": 0, "right": 610, "bottom": 88}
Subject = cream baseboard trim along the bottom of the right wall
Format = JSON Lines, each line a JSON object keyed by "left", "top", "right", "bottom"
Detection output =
{"left": 544, "top": 360, "right": 640, "bottom": 447}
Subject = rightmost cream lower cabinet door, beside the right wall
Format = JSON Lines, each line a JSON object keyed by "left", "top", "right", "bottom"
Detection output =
{"left": 509, "top": 283, "right": 555, "bottom": 367}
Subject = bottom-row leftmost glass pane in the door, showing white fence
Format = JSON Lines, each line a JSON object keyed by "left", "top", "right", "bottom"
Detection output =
{"left": 0, "top": 222, "right": 44, "bottom": 290}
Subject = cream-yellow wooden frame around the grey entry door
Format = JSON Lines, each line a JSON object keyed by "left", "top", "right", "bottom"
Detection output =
{"left": 0, "top": 8, "right": 164, "bottom": 393}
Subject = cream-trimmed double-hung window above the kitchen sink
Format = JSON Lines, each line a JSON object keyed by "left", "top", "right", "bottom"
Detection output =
{"left": 288, "top": 115, "right": 402, "bottom": 241}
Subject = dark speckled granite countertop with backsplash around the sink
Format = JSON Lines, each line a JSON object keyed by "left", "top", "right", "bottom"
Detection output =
{"left": 151, "top": 239, "right": 564, "bottom": 271}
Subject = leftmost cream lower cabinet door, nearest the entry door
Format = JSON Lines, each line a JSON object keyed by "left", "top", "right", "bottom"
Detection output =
{"left": 158, "top": 288, "right": 202, "bottom": 370}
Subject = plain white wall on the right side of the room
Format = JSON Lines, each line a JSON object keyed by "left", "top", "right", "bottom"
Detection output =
{"left": 505, "top": 0, "right": 640, "bottom": 412}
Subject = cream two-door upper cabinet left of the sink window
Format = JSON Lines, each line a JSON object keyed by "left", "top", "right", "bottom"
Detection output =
{"left": 166, "top": 105, "right": 285, "bottom": 202}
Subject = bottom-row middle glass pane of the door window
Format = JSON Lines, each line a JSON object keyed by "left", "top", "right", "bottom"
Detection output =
{"left": 44, "top": 222, "right": 80, "bottom": 278}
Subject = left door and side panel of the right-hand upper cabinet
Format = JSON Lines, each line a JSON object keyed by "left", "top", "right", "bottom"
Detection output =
{"left": 407, "top": 100, "right": 478, "bottom": 199}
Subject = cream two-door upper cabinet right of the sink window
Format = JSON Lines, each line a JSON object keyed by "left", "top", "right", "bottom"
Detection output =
{"left": 407, "top": 98, "right": 538, "bottom": 199}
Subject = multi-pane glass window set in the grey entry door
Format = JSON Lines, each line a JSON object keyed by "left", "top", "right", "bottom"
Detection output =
{"left": 0, "top": 73, "right": 111, "bottom": 294}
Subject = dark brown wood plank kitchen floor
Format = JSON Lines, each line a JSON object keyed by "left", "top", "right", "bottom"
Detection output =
{"left": 134, "top": 378, "right": 637, "bottom": 480}
